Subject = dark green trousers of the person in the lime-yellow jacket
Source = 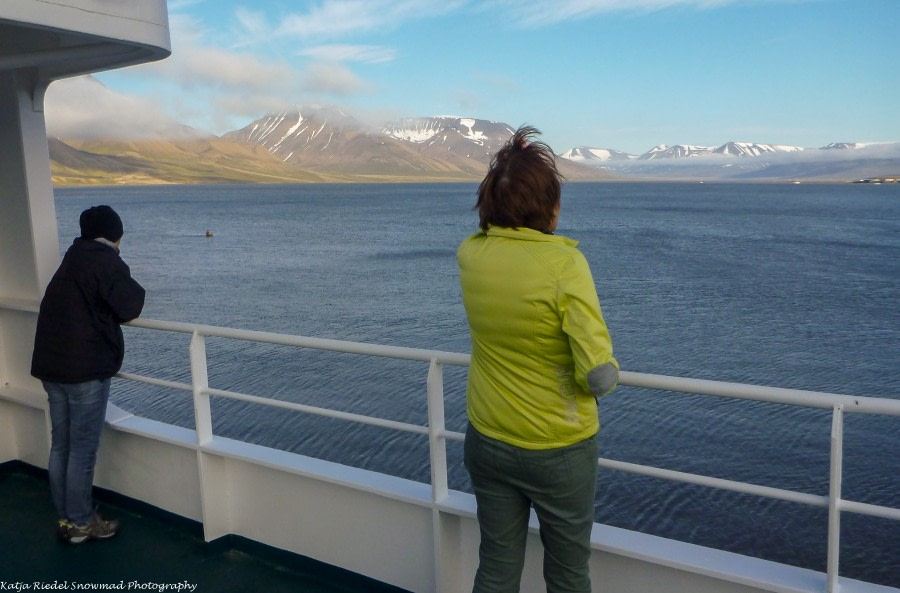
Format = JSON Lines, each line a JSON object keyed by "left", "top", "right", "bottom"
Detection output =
{"left": 464, "top": 424, "right": 597, "bottom": 593}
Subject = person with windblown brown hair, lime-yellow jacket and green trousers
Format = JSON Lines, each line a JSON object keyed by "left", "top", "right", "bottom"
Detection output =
{"left": 457, "top": 127, "right": 619, "bottom": 593}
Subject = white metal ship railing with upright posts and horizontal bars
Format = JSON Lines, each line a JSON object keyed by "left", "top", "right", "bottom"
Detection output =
{"left": 118, "top": 319, "right": 900, "bottom": 593}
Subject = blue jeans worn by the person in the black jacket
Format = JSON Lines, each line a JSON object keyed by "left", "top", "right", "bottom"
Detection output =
{"left": 43, "top": 379, "right": 110, "bottom": 526}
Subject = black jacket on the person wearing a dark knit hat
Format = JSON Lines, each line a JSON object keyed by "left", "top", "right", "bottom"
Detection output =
{"left": 31, "top": 238, "right": 144, "bottom": 383}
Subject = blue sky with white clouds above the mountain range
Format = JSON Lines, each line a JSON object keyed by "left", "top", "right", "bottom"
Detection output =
{"left": 46, "top": 0, "right": 900, "bottom": 154}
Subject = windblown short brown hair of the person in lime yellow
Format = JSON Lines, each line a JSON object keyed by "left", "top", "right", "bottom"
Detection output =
{"left": 475, "top": 126, "right": 563, "bottom": 232}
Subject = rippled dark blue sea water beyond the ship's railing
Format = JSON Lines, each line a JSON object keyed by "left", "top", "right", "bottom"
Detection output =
{"left": 56, "top": 184, "right": 900, "bottom": 586}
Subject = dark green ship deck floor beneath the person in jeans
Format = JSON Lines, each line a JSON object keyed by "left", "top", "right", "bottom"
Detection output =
{"left": 0, "top": 461, "right": 403, "bottom": 593}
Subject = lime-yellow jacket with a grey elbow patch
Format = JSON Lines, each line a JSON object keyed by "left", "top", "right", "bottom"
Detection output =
{"left": 457, "top": 227, "right": 618, "bottom": 449}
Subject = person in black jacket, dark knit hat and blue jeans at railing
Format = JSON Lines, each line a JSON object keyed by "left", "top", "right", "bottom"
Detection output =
{"left": 31, "top": 206, "right": 144, "bottom": 543}
